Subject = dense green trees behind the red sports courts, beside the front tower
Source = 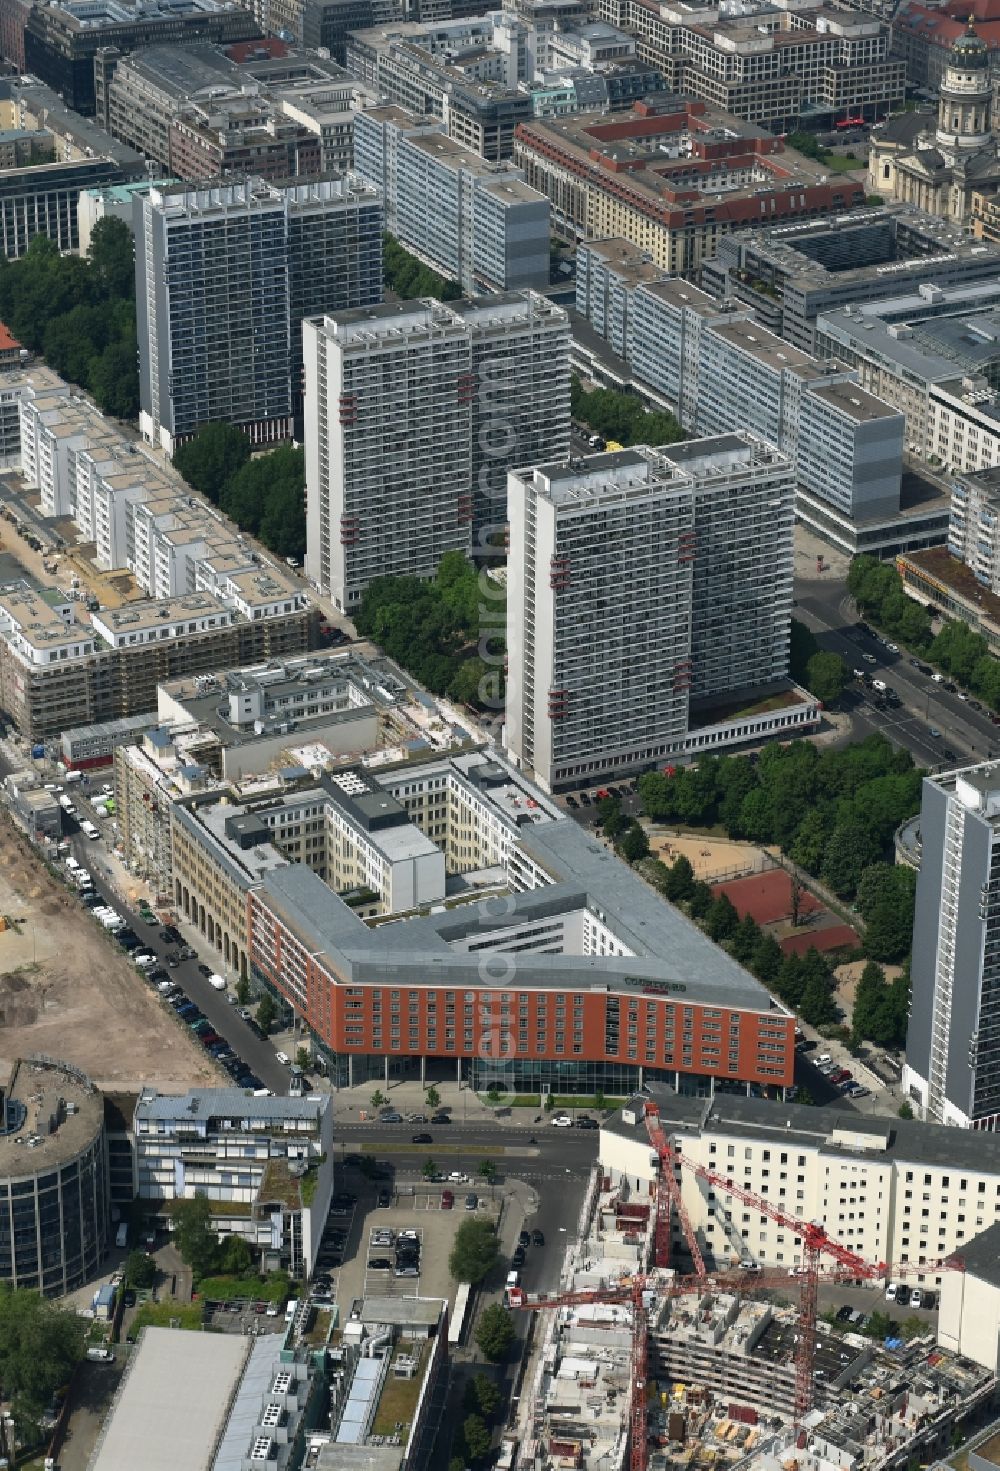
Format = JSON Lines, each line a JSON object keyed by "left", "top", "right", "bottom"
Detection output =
{"left": 638, "top": 734, "right": 921, "bottom": 906}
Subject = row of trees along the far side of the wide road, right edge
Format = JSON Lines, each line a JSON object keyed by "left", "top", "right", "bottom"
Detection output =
{"left": 847, "top": 556, "right": 1000, "bottom": 710}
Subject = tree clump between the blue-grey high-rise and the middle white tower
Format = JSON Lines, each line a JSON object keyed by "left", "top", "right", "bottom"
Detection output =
{"left": 174, "top": 424, "right": 306, "bottom": 562}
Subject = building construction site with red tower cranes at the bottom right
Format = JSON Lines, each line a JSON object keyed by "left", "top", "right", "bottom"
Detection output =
{"left": 501, "top": 1108, "right": 997, "bottom": 1471}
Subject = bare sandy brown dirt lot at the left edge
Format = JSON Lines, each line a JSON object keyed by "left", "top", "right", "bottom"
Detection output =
{"left": 0, "top": 822, "right": 221, "bottom": 1090}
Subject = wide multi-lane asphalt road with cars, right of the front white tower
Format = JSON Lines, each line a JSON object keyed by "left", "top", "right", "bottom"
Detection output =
{"left": 796, "top": 581, "right": 1000, "bottom": 766}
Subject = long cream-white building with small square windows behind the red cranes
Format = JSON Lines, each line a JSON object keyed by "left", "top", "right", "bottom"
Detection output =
{"left": 600, "top": 1084, "right": 1000, "bottom": 1288}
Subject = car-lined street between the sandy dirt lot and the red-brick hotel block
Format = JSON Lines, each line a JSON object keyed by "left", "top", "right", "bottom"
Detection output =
{"left": 63, "top": 786, "right": 288, "bottom": 1094}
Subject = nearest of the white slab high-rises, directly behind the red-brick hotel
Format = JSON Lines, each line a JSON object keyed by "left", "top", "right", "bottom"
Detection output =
{"left": 504, "top": 434, "right": 815, "bottom": 791}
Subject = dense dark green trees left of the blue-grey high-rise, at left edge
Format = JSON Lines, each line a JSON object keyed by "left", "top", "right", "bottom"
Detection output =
{"left": 0, "top": 219, "right": 138, "bottom": 419}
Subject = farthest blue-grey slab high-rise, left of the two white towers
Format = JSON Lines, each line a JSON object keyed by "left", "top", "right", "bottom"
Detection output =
{"left": 134, "top": 175, "right": 382, "bottom": 455}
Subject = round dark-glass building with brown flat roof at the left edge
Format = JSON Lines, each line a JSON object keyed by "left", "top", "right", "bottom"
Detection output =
{"left": 0, "top": 1058, "right": 110, "bottom": 1297}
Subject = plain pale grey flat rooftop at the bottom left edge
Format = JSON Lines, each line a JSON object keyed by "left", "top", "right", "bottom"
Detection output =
{"left": 88, "top": 1328, "right": 253, "bottom": 1471}
